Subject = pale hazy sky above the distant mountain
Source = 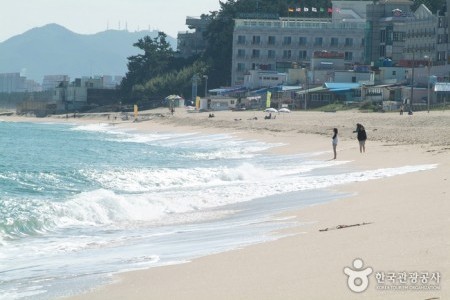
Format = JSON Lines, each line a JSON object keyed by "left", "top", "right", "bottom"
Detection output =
{"left": 0, "top": 0, "right": 221, "bottom": 42}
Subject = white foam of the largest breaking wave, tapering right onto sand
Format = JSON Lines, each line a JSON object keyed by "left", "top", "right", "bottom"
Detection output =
{"left": 45, "top": 162, "right": 436, "bottom": 226}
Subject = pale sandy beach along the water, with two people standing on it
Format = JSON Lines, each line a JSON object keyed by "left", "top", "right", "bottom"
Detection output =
{"left": 4, "top": 109, "right": 450, "bottom": 299}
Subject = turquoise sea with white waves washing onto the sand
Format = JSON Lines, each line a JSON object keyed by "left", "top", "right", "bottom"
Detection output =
{"left": 0, "top": 122, "right": 434, "bottom": 299}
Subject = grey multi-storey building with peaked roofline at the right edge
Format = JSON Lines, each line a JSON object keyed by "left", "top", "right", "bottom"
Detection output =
{"left": 366, "top": 0, "right": 450, "bottom": 67}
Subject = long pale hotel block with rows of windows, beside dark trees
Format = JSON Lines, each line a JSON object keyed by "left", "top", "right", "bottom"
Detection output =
{"left": 231, "top": 1, "right": 370, "bottom": 85}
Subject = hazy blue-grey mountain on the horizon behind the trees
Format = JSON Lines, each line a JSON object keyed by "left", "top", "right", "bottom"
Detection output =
{"left": 0, "top": 24, "right": 176, "bottom": 83}
